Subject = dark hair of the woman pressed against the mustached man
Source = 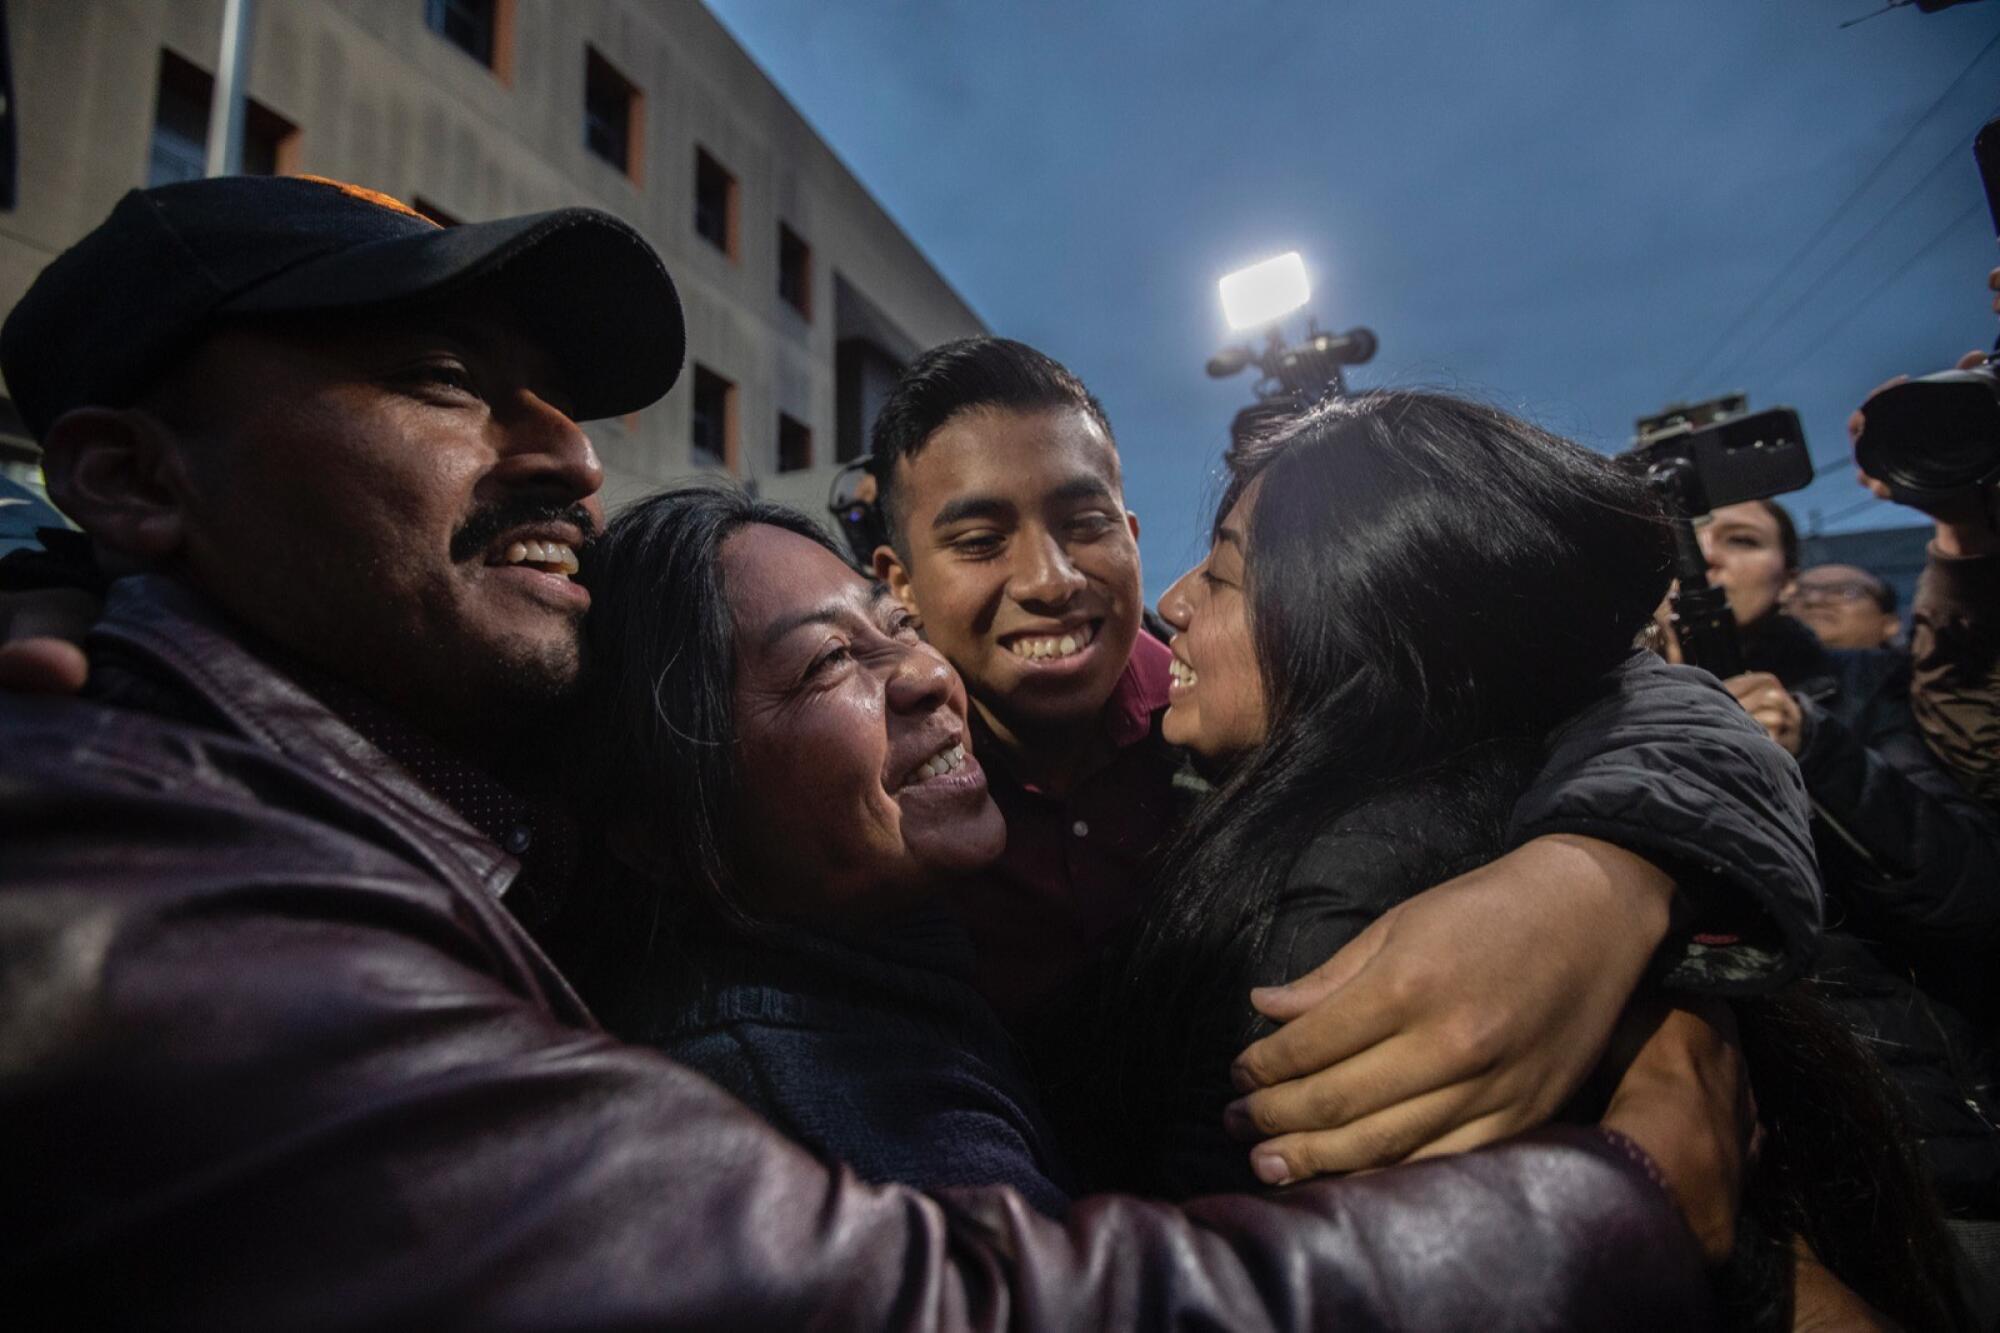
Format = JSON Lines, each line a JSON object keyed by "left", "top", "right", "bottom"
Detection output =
{"left": 560, "top": 484, "right": 844, "bottom": 1027}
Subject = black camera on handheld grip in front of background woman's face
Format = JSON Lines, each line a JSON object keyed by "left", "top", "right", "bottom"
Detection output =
{"left": 1622, "top": 394, "right": 1812, "bottom": 679}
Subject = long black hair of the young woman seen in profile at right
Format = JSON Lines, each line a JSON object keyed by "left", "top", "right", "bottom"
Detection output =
{"left": 1070, "top": 390, "right": 1958, "bottom": 1329}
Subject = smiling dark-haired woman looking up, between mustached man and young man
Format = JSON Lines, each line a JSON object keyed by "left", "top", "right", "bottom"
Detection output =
{"left": 572, "top": 486, "right": 1066, "bottom": 1213}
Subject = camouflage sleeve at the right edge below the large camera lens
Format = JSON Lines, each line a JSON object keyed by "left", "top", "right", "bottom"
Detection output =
{"left": 1910, "top": 550, "right": 2000, "bottom": 811}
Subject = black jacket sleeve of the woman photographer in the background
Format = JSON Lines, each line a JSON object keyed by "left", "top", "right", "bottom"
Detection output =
{"left": 1798, "top": 652, "right": 2000, "bottom": 944}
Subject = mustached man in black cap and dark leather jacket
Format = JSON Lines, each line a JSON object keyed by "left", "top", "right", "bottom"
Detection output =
{"left": 0, "top": 178, "right": 1736, "bottom": 1329}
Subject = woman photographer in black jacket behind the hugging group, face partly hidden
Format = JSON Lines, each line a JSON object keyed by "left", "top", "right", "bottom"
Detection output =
{"left": 1672, "top": 490, "right": 2000, "bottom": 1299}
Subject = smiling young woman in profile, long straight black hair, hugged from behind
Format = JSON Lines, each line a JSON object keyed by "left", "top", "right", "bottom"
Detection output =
{"left": 1064, "top": 392, "right": 1952, "bottom": 1327}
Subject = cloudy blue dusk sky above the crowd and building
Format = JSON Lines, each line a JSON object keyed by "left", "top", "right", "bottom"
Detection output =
{"left": 710, "top": 0, "right": 2000, "bottom": 594}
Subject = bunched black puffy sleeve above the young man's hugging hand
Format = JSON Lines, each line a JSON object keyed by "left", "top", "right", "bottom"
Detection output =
{"left": 1512, "top": 652, "right": 1820, "bottom": 995}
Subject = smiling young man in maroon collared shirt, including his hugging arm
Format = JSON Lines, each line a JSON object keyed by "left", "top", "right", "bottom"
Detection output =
{"left": 874, "top": 338, "right": 1816, "bottom": 1179}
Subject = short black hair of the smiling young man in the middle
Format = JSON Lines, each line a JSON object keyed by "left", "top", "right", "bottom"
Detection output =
{"left": 870, "top": 336, "right": 1116, "bottom": 558}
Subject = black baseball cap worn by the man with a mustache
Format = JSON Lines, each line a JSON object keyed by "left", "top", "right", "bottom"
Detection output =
{"left": 0, "top": 176, "right": 686, "bottom": 438}
